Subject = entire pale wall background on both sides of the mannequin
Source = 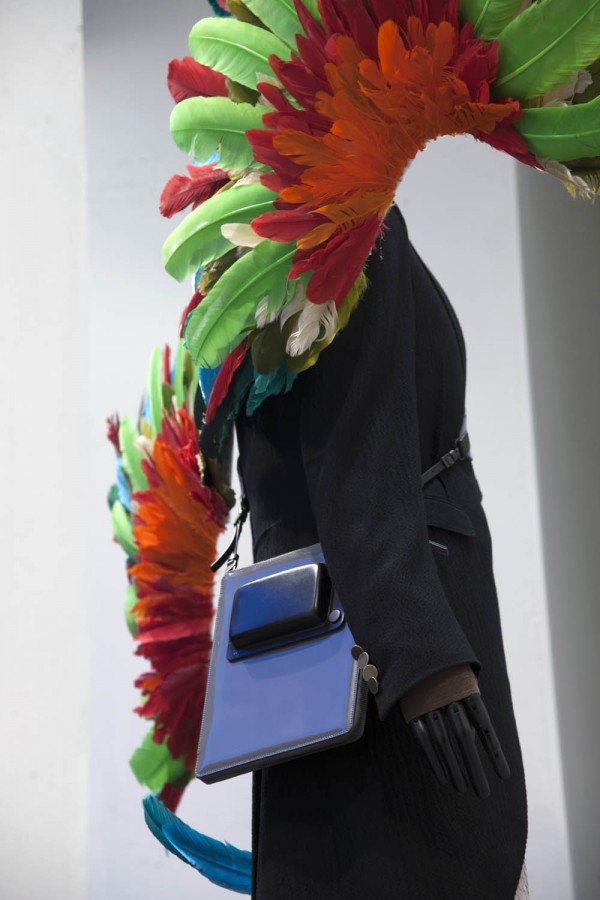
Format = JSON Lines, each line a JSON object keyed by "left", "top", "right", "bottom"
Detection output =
{"left": 0, "top": 0, "right": 600, "bottom": 900}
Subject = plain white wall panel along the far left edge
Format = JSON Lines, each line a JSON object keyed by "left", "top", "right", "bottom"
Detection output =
{"left": 0, "top": 0, "right": 90, "bottom": 900}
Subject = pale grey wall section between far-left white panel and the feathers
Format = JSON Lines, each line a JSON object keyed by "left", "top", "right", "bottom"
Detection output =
{"left": 84, "top": 0, "right": 250, "bottom": 900}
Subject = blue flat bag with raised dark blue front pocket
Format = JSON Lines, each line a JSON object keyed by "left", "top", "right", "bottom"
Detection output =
{"left": 196, "top": 544, "right": 368, "bottom": 783}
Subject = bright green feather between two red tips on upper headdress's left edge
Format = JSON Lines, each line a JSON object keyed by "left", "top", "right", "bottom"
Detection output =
{"left": 171, "top": 97, "right": 265, "bottom": 172}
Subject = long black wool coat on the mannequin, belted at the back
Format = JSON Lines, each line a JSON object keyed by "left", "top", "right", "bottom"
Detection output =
{"left": 236, "top": 207, "right": 527, "bottom": 900}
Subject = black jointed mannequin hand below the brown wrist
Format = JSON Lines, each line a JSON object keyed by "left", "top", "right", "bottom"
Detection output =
{"left": 408, "top": 694, "right": 510, "bottom": 799}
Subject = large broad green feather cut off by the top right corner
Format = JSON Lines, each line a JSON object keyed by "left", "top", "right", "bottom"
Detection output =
{"left": 492, "top": 0, "right": 600, "bottom": 100}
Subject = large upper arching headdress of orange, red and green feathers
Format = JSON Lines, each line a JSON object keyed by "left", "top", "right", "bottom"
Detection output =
{"left": 162, "top": 0, "right": 600, "bottom": 450}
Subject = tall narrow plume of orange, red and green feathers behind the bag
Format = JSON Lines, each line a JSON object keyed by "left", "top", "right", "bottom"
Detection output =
{"left": 109, "top": 342, "right": 232, "bottom": 810}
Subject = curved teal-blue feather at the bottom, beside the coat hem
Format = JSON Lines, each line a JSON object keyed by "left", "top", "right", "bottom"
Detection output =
{"left": 144, "top": 795, "right": 252, "bottom": 894}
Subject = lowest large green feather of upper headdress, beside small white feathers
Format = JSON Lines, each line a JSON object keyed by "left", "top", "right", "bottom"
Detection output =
{"left": 185, "top": 241, "right": 296, "bottom": 368}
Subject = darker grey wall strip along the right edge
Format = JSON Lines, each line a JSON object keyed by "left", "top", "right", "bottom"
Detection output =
{"left": 519, "top": 165, "right": 600, "bottom": 900}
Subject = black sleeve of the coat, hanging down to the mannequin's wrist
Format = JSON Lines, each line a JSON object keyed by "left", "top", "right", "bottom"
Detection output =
{"left": 300, "top": 211, "right": 479, "bottom": 719}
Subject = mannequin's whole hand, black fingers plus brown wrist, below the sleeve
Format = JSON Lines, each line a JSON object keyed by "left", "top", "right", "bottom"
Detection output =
{"left": 401, "top": 666, "right": 510, "bottom": 799}
